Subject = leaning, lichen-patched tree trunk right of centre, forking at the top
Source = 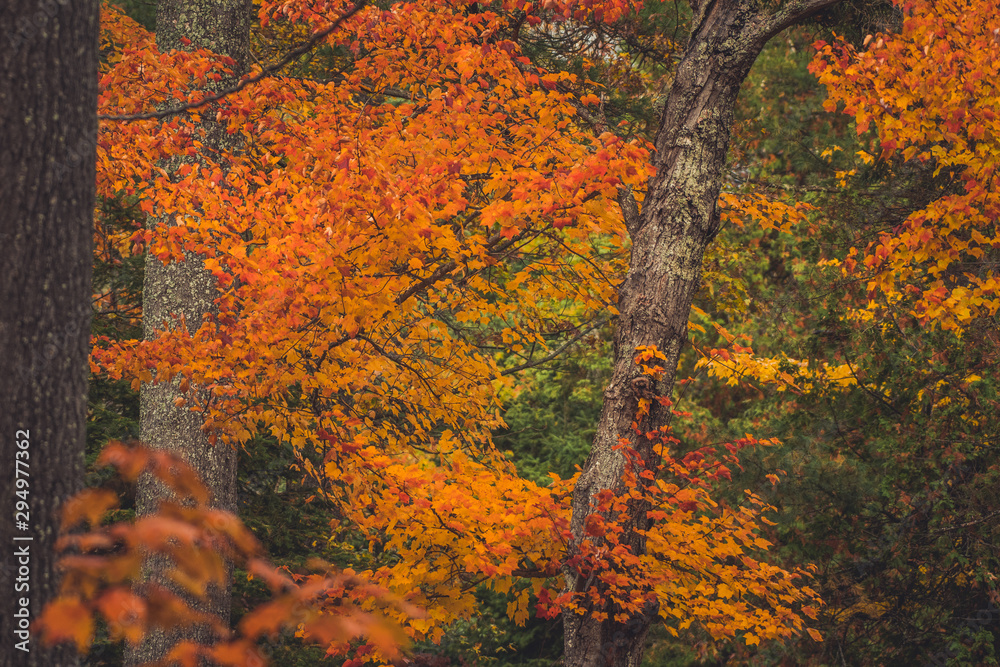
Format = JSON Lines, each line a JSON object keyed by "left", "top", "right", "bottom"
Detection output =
{"left": 563, "top": 0, "right": 838, "bottom": 667}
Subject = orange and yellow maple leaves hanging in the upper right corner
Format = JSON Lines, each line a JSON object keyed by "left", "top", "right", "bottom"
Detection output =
{"left": 812, "top": 0, "right": 1000, "bottom": 330}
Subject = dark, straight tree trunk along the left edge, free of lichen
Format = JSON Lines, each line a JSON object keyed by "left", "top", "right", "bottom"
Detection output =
{"left": 0, "top": 0, "right": 99, "bottom": 667}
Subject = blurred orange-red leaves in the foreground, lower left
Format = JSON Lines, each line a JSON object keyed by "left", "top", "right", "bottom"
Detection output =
{"left": 39, "top": 442, "right": 422, "bottom": 666}
